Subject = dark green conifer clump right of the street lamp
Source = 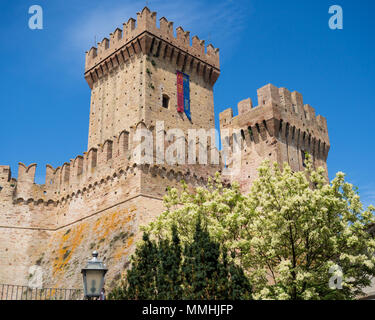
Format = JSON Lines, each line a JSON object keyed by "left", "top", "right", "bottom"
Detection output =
{"left": 108, "top": 219, "right": 251, "bottom": 300}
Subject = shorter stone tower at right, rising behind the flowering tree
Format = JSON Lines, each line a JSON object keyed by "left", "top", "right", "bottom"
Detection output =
{"left": 220, "top": 84, "right": 330, "bottom": 192}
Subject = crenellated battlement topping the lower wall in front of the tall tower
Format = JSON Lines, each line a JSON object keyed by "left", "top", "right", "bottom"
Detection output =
{"left": 0, "top": 122, "right": 221, "bottom": 206}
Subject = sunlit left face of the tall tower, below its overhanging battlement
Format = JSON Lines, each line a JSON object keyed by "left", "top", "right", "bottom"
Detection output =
{"left": 88, "top": 54, "right": 145, "bottom": 149}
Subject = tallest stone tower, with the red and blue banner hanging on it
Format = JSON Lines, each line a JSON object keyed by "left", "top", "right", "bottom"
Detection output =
{"left": 85, "top": 7, "right": 220, "bottom": 150}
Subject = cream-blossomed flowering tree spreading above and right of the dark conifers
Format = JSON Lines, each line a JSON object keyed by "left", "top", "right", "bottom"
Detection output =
{"left": 145, "top": 157, "right": 375, "bottom": 299}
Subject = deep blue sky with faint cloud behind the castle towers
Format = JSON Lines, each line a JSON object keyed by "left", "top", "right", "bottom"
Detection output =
{"left": 0, "top": 0, "right": 375, "bottom": 205}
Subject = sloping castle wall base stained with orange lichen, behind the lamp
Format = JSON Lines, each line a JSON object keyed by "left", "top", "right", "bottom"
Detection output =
{"left": 37, "top": 196, "right": 166, "bottom": 288}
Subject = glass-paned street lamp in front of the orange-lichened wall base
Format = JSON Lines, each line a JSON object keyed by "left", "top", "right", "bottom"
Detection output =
{"left": 81, "top": 251, "right": 108, "bottom": 299}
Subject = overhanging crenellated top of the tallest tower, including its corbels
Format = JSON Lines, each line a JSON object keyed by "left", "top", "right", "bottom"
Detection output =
{"left": 85, "top": 7, "right": 220, "bottom": 88}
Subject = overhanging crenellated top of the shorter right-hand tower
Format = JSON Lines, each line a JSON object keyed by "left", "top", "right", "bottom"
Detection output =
{"left": 219, "top": 84, "right": 330, "bottom": 165}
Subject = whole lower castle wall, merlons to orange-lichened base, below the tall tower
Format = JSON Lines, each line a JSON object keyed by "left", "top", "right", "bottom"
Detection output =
{"left": 0, "top": 129, "right": 219, "bottom": 288}
